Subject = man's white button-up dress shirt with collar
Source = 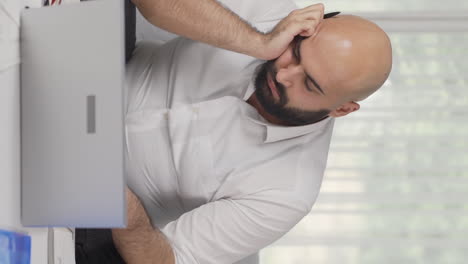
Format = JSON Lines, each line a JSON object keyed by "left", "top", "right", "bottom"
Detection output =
{"left": 126, "top": 0, "right": 333, "bottom": 264}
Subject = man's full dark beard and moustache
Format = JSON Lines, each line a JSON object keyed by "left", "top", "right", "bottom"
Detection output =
{"left": 255, "top": 60, "right": 330, "bottom": 126}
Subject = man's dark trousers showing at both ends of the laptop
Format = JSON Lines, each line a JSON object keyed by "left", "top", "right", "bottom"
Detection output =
{"left": 75, "top": 0, "right": 135, "bottom": 264}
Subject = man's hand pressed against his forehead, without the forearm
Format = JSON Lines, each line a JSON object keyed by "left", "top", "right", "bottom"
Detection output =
{"left": 257, "top": 4, "right": 324, "bottom": 60}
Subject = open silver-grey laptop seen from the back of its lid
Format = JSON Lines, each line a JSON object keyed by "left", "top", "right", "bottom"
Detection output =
{"left": 21, "top": 0, "right": 126, "bottom": 228}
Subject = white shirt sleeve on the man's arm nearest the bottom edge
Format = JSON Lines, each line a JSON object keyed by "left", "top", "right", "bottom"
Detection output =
{"left": 161, "top": 190, "right": 310, "bottom": 264}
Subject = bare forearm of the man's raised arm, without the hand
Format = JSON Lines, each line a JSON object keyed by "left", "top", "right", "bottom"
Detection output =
{"left": 133, "top": 0, "right": 266, "bottom": 57}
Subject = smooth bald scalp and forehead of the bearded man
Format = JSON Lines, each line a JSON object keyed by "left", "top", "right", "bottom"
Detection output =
{"left": 304, "top": 15, "right": 392, "bottom": 101}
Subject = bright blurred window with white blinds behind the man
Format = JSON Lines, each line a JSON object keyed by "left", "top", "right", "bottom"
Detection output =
{"left": 260, "top": 0, "right": 468, "bottom": 264}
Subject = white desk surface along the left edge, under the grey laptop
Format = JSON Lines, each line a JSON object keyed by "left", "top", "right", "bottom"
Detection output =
{"left": 0, "top": 0, "right": 47, "bottom": 264}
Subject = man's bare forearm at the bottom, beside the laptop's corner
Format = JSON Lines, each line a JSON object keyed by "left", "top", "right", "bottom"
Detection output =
{"left": 112, "top": 190, "right": 175, "bottom": 264}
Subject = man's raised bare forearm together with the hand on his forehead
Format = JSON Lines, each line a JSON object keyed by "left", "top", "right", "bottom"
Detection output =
{"left": 132, "top": 0, "right": 324, "bottom": 60}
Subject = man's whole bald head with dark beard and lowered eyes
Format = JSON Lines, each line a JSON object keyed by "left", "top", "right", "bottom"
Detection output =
{"left": 252, "top": 15, "right": 392, "bottom": 125}
